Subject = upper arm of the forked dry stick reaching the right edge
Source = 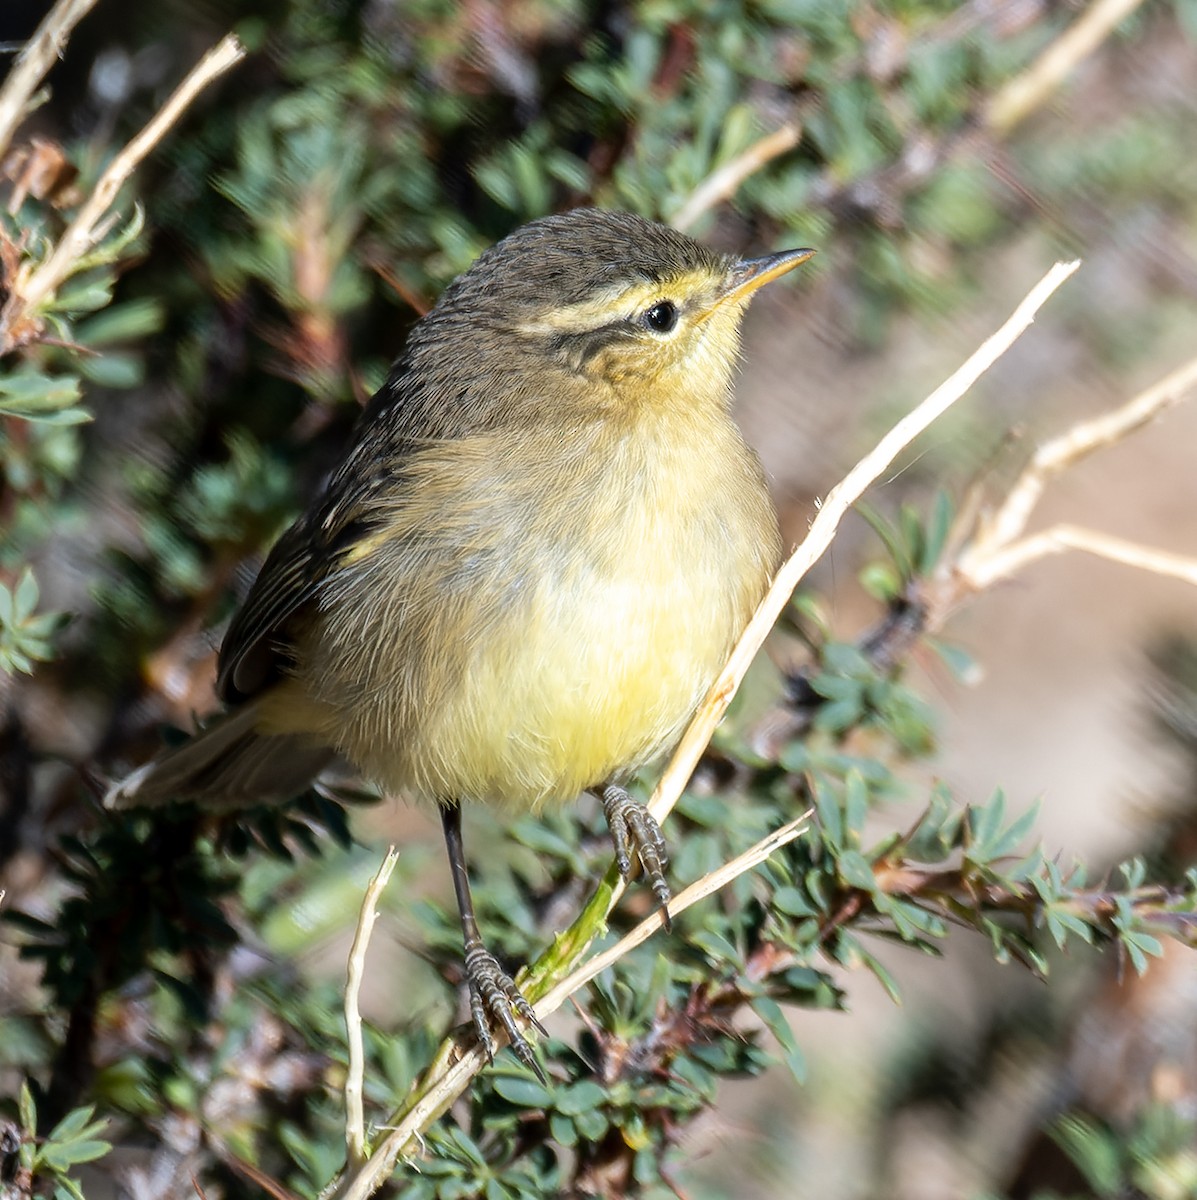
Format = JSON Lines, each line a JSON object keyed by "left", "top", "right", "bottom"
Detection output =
{"left": 955, "top": 358, "right": 1197, "bottom": 576}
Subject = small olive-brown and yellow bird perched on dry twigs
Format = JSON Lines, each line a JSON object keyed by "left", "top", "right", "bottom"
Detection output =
{"left": 108, "top": 209, "right": 814, "bottom": 1074}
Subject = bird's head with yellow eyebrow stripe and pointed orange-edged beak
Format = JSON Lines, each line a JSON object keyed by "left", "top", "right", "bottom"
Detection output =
{"left": 410, "top": 209, "right": 814, "bottom": 422}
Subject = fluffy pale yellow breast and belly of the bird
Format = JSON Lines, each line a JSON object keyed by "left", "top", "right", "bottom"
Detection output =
{"left": 284, "top": 408, "right": 778, "bottom": 806}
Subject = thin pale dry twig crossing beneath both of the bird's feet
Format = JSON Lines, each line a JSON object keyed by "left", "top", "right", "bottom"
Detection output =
{"left": 335, "top": 812, "right": 811, "bottom": 1200}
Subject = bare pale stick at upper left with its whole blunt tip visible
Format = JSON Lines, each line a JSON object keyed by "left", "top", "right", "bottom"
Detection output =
{"left": 10, "top": 34, "right": 245, "bottom": 328}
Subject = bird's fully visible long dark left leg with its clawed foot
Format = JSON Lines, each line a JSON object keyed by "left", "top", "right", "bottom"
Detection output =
{"left": 440, "top": 800, "right": 547, "bottom": 1084}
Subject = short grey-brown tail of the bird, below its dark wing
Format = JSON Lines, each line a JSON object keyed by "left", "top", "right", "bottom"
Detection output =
{"left": 104, "top": 700, "right": 336, "bottom": 809}
